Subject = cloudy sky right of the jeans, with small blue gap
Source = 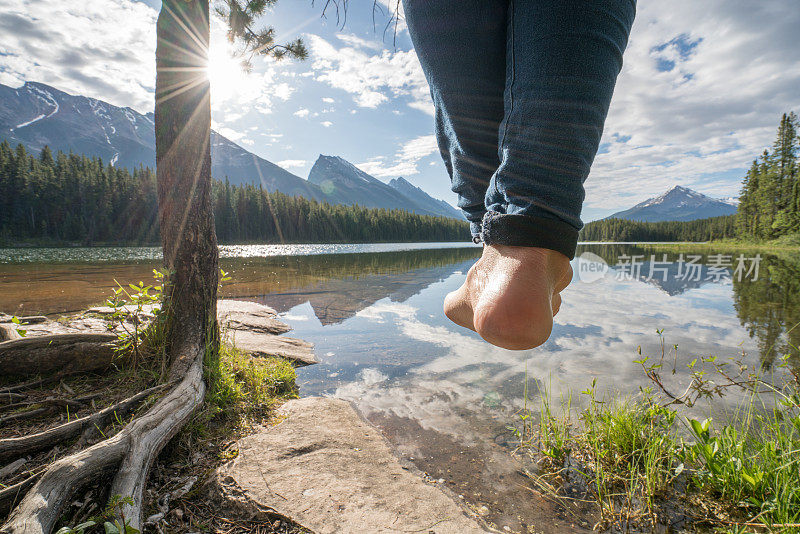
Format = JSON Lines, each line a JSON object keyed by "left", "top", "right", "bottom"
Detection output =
{"left": 586, "top": 0, "right": 800, "bottom": 211}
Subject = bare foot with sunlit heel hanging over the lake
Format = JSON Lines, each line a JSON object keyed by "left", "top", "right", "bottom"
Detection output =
{"left": 444, "top": 245, "right": 572, "bottom": 350}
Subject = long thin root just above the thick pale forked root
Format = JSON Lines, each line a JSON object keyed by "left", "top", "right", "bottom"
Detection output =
{"left": 0, "top": 384, "right": 167, "bottom": 462}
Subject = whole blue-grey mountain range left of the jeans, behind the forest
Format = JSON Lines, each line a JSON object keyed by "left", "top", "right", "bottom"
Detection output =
{"left": 0, "top": 82, "right": 462, "bottom": 218}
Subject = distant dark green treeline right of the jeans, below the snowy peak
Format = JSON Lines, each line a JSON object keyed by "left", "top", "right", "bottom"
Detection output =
{"left": 579, "top": 215, "right": 736, "bottom": 242}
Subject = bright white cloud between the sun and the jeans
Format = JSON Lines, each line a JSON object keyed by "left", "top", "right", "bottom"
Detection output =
{"left": 308, "top": 35, "right": 433, "bottom": 114}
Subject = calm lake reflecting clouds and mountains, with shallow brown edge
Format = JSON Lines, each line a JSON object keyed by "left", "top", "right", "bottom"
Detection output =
{"left": 0, "top": 243, "right": 800, "bottom": 532}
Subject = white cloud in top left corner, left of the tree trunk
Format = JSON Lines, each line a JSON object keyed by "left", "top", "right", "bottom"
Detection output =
{"left": 0, "top": 0, "right": 157, "bottom": 112}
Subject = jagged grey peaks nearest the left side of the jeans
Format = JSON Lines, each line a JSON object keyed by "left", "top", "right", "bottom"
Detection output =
{"left": 308, "top": 154, "right": 461, "bottom": 218}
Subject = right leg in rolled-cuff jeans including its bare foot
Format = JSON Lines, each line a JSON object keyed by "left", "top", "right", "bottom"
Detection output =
{"left": 445, "top": 0, "right": 635, "bottom": 349}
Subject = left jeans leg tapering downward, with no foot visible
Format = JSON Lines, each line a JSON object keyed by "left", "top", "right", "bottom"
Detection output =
{"left": 403, "top": 0, "right": 508, "bottom": 237}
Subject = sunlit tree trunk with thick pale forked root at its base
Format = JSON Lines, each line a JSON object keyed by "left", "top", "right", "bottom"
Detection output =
{"left": 0, "top": 0, "right": 219, "bottom": 534}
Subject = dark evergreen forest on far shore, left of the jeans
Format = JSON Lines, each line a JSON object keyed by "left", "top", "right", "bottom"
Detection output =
{"left": 0, "top": 141, "right": 470, "bottom": 244}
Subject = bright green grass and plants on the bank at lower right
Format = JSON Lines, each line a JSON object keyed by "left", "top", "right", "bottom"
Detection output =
{"left": 517, "top": 342, "right": 800, "bottom": 533}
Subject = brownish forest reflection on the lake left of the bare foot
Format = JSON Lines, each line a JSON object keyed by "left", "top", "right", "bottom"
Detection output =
{"left": 0, "top": 247, "right": 480, "bottom": 318}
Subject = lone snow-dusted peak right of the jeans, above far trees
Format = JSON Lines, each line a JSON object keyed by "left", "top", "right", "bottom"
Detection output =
{"left": 608, "top": 185, "right": 736, "bottom": 222}
